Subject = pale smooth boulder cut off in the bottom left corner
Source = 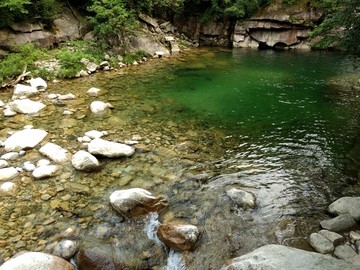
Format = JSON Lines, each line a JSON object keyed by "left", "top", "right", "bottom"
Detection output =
{"left": 0, "top": 252, "right": 74, "bottom": 270}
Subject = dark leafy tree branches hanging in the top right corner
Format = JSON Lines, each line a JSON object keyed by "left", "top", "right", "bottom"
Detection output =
{"left": 312, "top": 0, "right": 360, "bottom": 55}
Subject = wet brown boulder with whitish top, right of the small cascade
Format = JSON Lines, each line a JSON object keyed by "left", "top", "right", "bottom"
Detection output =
{"left": 156, "top": 224, "right": 200, "bottom": 251}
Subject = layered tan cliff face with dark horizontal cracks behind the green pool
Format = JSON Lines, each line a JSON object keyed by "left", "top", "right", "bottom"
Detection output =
{"left": 232, "top": 2, "right": 323, "bottom": 48}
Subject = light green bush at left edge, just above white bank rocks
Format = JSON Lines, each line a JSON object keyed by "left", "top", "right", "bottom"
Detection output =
{"left": 0, "top": 44, "right": 45, "bottom": 84}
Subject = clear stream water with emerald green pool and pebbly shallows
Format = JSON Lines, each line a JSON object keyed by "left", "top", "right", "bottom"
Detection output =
{"left": 0, "top": 48, "right": 360, "bottom": 270}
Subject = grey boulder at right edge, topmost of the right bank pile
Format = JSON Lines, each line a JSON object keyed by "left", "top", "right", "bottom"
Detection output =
{"left": 329, "top": 197, "right": 360, "bottom": 221}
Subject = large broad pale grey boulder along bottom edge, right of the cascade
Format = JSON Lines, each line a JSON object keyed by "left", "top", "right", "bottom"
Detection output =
{"left": 221, "top": 245, "right": 360, "bottom": 270}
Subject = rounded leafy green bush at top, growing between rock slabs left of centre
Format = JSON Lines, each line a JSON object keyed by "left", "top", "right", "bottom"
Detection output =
{"left": 88, "top": 0, "right": 137, "bottom": 37}
